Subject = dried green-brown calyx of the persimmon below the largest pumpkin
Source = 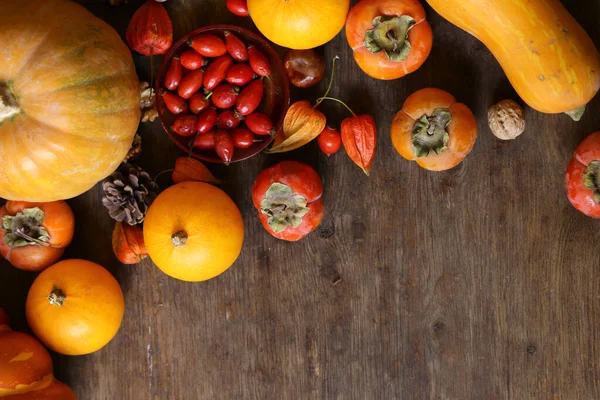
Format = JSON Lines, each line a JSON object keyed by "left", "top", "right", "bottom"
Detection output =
{"left": 2, "top": 207, "right": 50, "bottom": 247}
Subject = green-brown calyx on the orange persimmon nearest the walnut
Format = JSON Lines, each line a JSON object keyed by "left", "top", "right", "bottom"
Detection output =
{"left": 412, "top": 108, "right": 452, "bottom": 157}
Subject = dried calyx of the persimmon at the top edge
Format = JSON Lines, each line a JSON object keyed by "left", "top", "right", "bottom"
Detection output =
{"left": 364, "top": 15, "right": 416, "bottom": 62}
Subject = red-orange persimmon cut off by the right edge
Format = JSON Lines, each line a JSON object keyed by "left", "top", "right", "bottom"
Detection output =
{"left": 565, "top": 132, "right": 600, "bottom": 218}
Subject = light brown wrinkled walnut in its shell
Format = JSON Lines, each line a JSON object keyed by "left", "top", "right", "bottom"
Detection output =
{"left": 488, "top": 100, "right": 525, "bottom": 140}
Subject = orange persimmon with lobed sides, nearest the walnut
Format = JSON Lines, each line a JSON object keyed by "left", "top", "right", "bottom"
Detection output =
{"left": 391, "top": 88, "right": 477, "bottom": 171}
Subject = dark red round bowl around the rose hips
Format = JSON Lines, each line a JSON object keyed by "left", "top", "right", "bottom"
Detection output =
{"left": 154, "top": 25, "right": 290, "bottom": 164}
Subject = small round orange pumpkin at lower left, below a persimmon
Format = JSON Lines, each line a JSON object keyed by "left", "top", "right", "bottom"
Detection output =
{"left": 25, "top": 260, "right": 125, "bottom": 355}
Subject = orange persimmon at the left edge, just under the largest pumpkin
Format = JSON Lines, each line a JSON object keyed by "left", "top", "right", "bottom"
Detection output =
{"left": 0, "top": 200, "right": 75, "bottom": 271}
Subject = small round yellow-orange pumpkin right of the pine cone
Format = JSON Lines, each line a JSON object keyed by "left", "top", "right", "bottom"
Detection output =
{"left": 144, "top": 181, "right": 244, "bottom": 282}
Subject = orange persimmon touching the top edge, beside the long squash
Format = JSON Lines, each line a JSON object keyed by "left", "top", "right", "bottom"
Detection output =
{"left": 346, "top": 0, "right": 433, "bottom": 80}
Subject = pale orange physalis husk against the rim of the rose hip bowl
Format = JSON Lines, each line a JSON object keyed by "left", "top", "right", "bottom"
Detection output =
{"left": 267, "top": 100, "right": 327, "bottom": 153}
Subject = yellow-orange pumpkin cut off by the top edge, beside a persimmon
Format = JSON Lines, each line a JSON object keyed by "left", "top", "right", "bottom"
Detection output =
{"left": 248, "top": 0, "right": 350, "bottom": 50}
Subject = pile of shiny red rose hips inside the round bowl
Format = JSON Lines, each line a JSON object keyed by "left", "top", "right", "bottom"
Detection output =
{"left": 160, "top": 31, "right": 276, "bottom": 162}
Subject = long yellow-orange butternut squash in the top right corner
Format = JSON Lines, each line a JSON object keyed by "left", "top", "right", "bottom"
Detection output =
{"left": 427, "top": 0, "right": 600, "bottom": 114}
